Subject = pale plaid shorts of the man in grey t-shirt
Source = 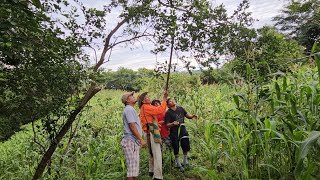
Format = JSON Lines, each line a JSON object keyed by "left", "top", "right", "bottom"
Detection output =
{"left": 121, "top": 139, "right": 140, "bottom": 177}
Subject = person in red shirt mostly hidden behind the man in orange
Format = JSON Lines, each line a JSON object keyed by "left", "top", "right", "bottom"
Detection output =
{"left": 151, "top": 99, "right": 171, "bottom": 147}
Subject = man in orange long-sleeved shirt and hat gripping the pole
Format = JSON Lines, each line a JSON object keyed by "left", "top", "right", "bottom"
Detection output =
{"left": 138, "top": 91, "right": 168, "bottom": 180}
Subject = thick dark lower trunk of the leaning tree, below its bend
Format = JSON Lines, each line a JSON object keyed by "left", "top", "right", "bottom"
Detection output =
{"left": 33, "top": 83, "right": 101, "bottom": 180}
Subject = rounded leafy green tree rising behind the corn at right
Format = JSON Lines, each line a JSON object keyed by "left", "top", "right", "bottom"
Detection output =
{"left": 232, "top": 27, "right": 302, "bottom": 79}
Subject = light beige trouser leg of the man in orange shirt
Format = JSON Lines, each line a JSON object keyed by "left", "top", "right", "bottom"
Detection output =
{"left": 150, "top": 133, "right": 163, "bottom": 179}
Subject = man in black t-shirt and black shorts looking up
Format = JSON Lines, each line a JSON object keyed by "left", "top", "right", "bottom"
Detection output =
{"left": 165, "top": 98, "right": 198, "bottom": 170}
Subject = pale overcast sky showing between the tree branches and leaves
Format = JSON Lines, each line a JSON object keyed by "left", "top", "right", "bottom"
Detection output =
{"left": 82, "top": 0, "right": 288, "bottom": 70}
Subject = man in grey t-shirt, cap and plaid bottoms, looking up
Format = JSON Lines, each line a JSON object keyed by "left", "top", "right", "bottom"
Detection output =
{"left": 121, "top": 93, "right": 146, "bottom": 180}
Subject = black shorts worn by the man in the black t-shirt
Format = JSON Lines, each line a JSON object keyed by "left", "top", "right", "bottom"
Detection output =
{"left": 170, "top": 126, "right": 190, "bottom": 155}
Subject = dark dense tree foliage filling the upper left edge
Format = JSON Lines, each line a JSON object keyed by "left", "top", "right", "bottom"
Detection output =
{"left": 0, "top": 1, "right": 83, "bottom": 140}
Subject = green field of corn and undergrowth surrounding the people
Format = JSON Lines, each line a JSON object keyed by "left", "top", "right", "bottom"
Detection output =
{"left": 0, "top": 64, "right": 320, "bottom": 179}
